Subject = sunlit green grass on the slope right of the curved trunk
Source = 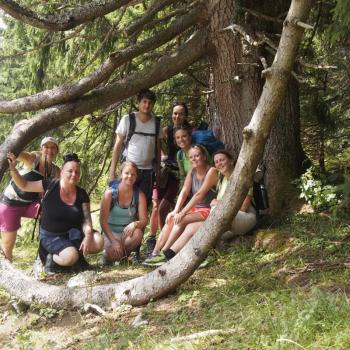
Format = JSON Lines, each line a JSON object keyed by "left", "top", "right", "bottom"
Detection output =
{"left": 0, "top": 215, "right": 350, "bottom": 350}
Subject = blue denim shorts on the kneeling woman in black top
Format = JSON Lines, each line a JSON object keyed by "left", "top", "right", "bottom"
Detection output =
{"left": 40, "top": 227, "right": 84, "bottom": 254}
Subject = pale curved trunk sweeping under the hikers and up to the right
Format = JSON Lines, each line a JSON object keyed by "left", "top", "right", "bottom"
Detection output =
{"left": 0, "top": 0, "right": 312, "bottom": 307}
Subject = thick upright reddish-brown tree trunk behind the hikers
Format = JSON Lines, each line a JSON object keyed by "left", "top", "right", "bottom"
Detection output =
{"left": 209, "top": 0, "right": 304, "bottom": 215}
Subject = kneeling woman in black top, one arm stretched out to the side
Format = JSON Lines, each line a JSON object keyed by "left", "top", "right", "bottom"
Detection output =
{"left": 7, "top": 153, "right": 103, "bottom": 273}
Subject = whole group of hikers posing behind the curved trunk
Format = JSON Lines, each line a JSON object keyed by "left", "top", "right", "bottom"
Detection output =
{"left": 0, "top": 89, "right": 256, "bottom": 273}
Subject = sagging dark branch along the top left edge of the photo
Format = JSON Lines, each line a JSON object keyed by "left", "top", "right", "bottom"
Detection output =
{"left": 0, "top": 0, "right": 133, "bottom": 31}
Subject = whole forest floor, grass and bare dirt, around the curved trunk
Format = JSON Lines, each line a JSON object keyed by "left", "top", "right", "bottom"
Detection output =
{"left": 0, "top": 206, "right": 350, "bottom": 350}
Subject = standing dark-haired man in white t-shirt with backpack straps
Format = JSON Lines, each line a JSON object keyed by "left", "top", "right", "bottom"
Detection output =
{"left": 109, "top": 90, "right": 163, "bottom": 206}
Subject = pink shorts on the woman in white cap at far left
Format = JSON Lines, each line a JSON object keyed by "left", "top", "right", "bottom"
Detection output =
{"left": 0, "top": 202, "right": 39, "bottom": 232}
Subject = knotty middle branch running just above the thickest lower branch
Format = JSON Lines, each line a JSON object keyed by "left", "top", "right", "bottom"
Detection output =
{"left": 0, "top": 6, "right": 201, "bottom": 113}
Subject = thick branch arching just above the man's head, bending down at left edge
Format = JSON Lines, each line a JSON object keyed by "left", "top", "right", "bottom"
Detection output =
{"left": 0, "top": 31, "right": 206, "bottom": 180}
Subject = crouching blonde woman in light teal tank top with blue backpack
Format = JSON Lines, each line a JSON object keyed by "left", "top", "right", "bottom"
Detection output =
{"left": 100, "top": 161, "right": 147, "bottom": 265}
